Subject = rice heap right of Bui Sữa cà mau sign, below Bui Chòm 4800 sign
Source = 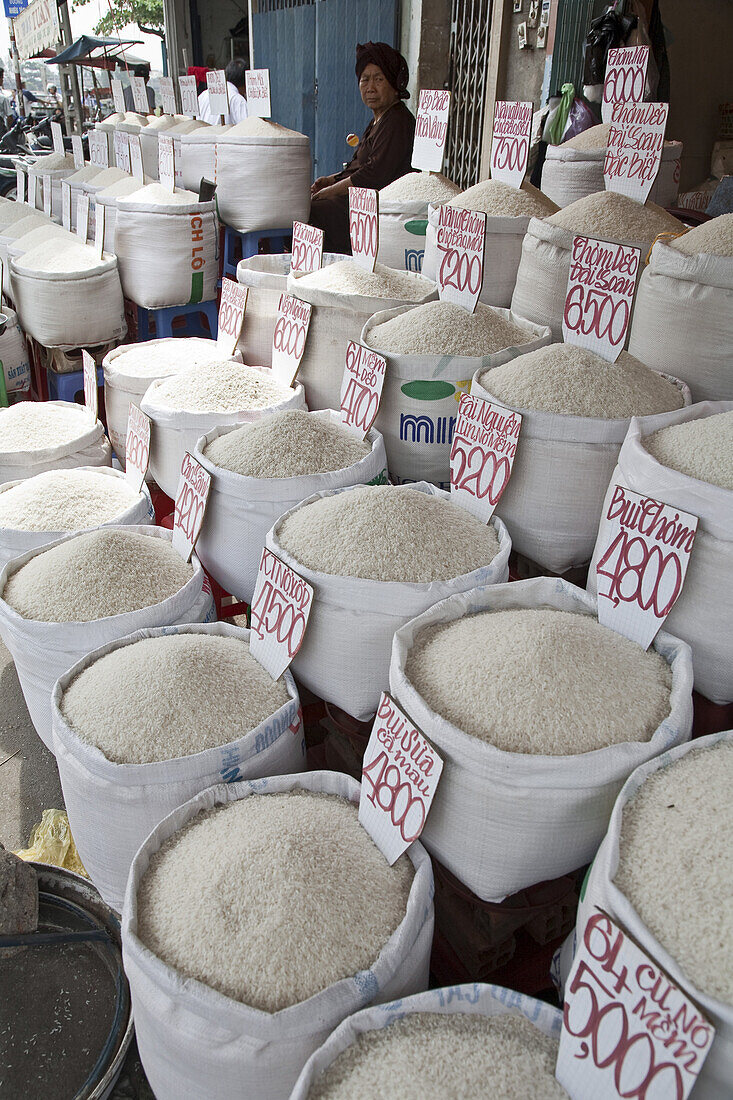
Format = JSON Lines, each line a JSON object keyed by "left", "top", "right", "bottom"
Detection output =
{"left": 405, "top": 609, "right": 671, "bottom": 756}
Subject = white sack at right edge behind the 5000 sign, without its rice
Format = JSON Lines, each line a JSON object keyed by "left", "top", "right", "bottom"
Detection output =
{"left": 562, "top": 730, "right": 733, "bottom": 1100}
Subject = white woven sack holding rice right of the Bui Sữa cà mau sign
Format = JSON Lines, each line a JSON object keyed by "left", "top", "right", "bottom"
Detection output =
{"left": 390, "top": 576, "right": 692, "bottom": 902}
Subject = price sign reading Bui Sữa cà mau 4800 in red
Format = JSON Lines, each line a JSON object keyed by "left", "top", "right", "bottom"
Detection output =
{"left": 359, "top": 692, "right": 442, "bottom": 864}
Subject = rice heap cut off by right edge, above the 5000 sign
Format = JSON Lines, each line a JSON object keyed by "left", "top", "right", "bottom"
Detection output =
{"left": 614, "top": 741, "right": 733, "bottom": 1004}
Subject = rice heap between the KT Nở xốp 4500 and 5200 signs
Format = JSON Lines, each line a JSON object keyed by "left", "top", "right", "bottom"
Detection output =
{"left": 277, "top": 485, "right": 499, "bottom": 584}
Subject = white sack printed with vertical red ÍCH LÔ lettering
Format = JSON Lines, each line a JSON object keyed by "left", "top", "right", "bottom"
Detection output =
{"left": 114, "top": 198, "right": 219, "bottom": 309}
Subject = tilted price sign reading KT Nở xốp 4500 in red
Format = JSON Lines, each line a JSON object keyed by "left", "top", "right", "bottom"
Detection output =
{"left": 250, "top": 549, "right": 313, "bottom": 680}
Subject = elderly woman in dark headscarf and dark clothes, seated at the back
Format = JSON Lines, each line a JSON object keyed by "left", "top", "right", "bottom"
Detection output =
{"left": 310, "top": 42, "right": 415, "bottom": 253}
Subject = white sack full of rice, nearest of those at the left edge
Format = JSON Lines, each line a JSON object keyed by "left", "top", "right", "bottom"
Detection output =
{"left": 0, "top": 525, "right": 216, "bottom": 749}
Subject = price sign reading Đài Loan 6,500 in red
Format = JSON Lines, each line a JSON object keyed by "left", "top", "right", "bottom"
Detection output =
{"left": 562, "top": 237, "right": 642, "bottom": 363}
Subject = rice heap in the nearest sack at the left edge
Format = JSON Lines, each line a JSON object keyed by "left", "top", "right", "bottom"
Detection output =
{"left": 0, "top": 528, "right": 194, "bottom": 623}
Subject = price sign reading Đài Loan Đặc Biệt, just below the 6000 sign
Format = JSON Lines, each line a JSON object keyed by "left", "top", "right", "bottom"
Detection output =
{"left": 603, "top": 102, "right": 669, "bottom": 202}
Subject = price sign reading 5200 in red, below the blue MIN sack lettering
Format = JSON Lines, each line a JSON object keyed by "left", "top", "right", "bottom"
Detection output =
{"left": 450, "top": 394, "right": 522, "bottom": 524}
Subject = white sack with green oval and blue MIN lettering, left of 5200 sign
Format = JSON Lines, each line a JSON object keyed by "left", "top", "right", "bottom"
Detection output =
{"left": 361, "top": 306, "right": 553, "bottom": 490}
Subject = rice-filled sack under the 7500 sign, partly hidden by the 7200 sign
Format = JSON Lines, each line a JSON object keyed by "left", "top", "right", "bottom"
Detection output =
{"left": 423, "top": 179, "right": 557, "bottom": 308}
